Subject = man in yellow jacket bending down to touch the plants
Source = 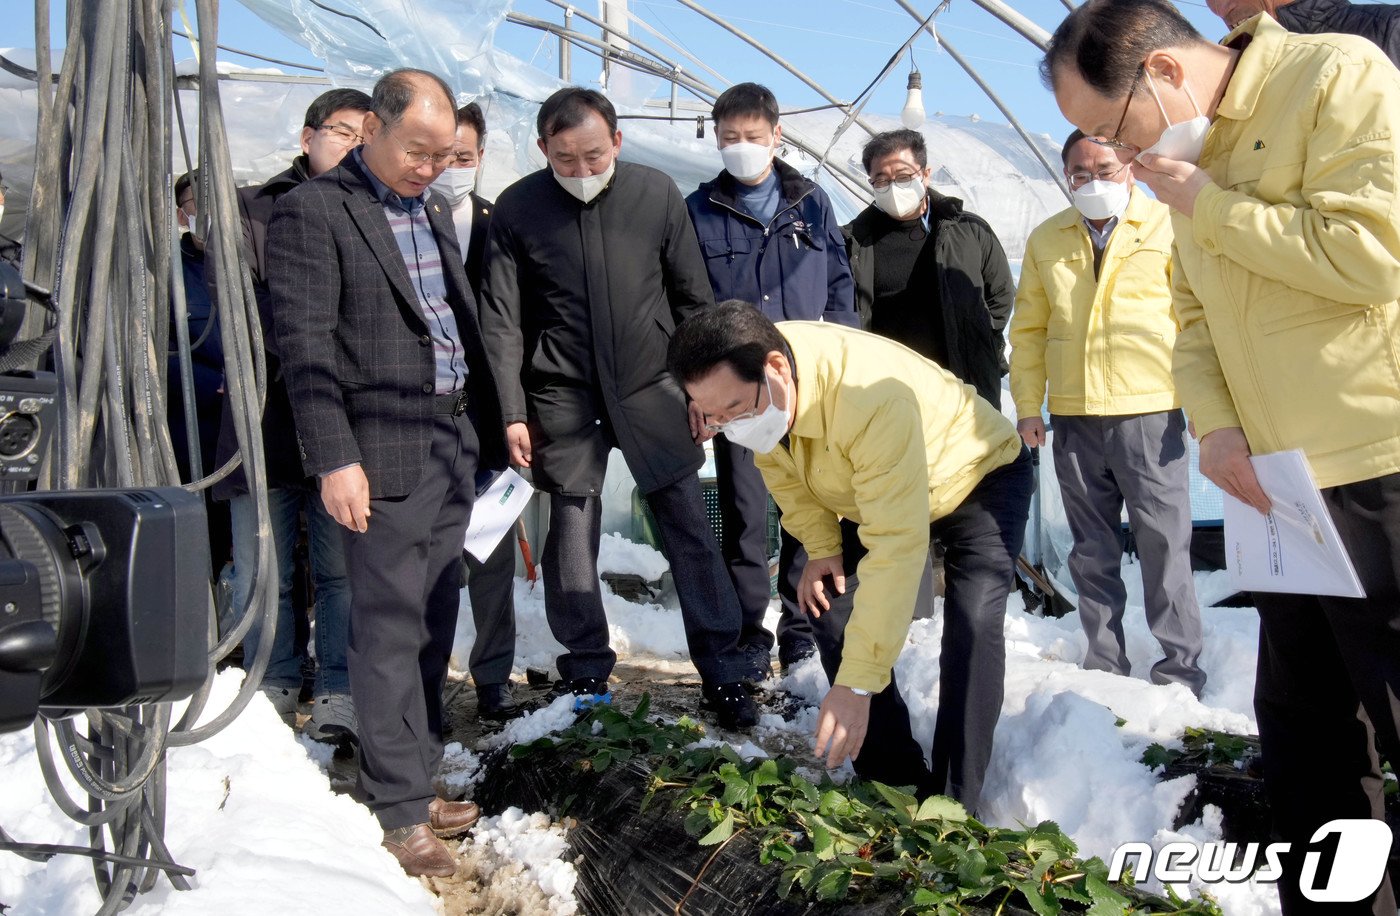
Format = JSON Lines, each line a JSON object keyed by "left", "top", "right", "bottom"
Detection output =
{"left": 668, "top": 301, "right": 1032, "bottom": 808}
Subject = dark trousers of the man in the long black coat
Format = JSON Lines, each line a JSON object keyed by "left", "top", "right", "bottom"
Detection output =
{"left": 540, "top": 475, "right": 745, "bottom": 685}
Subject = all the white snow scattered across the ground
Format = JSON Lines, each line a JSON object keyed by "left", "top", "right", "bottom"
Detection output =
{"left": 8, "top": 532, "right": 1278, "bottom": 916}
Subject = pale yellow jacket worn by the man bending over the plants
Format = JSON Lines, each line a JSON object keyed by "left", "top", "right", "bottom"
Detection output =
{"left": 756, "top": 321, "right": 1021, "bottom": 692}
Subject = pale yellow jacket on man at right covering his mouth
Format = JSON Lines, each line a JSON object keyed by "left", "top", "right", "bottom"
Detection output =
{"left": 1173, "top": 15, "right": 1400, "bottom": 487}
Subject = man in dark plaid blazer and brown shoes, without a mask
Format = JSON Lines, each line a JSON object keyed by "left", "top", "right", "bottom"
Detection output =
{"left": 267, "top": 70, "right": 507, "bottom": 875}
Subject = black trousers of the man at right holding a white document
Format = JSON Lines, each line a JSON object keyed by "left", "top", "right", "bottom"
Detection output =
{"left": 1254, "top": 473, "right": 1400, "bottom": 916}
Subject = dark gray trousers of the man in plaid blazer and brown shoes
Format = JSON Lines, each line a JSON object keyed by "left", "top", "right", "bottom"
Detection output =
{"left": 346, "top": 416, "right": 479, "bottom": 831}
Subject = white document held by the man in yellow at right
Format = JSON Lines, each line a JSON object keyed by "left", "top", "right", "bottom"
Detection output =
{"left": 1225, "top": 450, "right": 1366, "bottom": 598}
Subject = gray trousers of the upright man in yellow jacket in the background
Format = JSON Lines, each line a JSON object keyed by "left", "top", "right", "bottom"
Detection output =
{"left": 1051, "top": 410, "right": 1205, "bottom": 696}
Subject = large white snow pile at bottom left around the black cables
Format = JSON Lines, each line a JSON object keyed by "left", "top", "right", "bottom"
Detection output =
{"left": 0, "top": 671, "right": 437, "bottom": 916}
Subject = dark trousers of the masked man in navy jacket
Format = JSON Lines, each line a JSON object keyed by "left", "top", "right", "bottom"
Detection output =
{"left": 714, "top": 434, "right": 812, "bottom": 657}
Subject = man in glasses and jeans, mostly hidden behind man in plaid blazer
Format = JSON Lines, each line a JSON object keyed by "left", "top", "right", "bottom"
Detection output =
{"left": 213, "top": 90, "right": 370, "bottom": 744}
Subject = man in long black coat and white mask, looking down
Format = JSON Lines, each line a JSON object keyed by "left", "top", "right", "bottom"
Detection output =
{"left": 482, "top": 88, "right": 757, "bottom": 727}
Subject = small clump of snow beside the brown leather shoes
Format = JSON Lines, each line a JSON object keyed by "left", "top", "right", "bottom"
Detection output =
{"left": 458, "top": 808, "right": 578, "bottom": 916}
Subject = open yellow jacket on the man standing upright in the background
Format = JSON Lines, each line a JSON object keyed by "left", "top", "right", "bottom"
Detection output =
{"left": 1009, "top": 188, "right": 1180, "bottom": 420}
